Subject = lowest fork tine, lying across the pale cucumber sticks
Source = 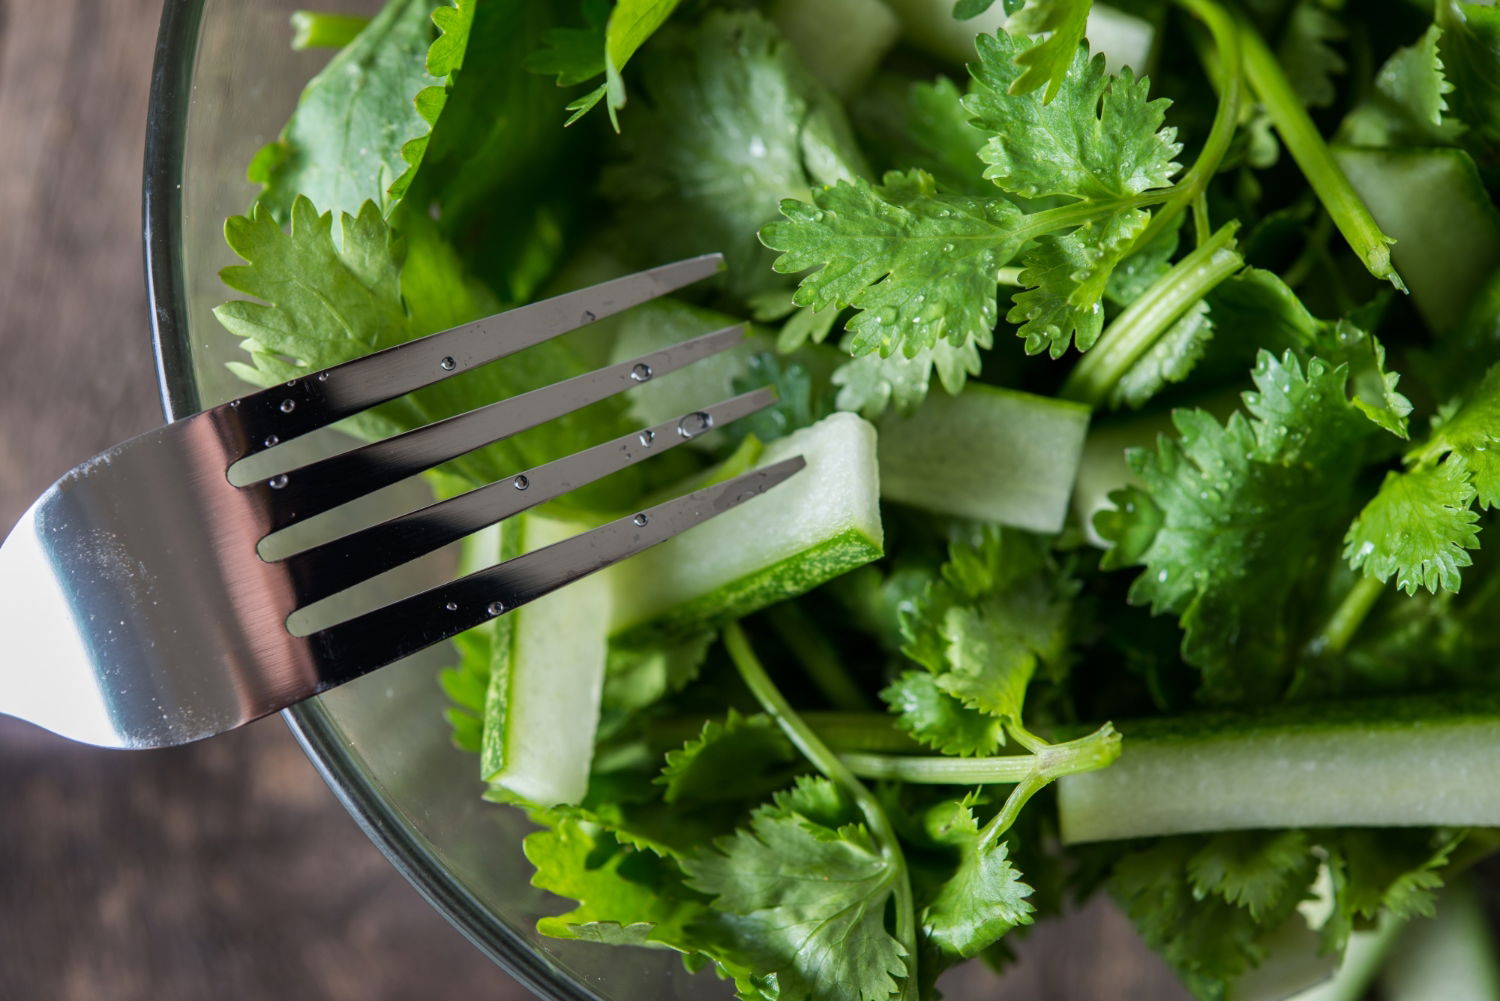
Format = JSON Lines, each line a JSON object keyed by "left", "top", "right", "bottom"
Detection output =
{"left": 308, "top": 456, "right": 806, "bottom": 687}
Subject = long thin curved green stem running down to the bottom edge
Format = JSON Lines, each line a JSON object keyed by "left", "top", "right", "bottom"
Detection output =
{"left": 725, "top": 623, "right": 918, "bottom": 1001}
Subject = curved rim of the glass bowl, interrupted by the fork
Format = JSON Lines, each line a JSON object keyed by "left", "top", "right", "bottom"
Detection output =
{"left": 141, "top": 0, "right": 602, "bottom": 1001}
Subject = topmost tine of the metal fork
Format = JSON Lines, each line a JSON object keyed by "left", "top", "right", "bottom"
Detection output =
{"left": 225, "top": 254, "right": 725, "bottom": 455}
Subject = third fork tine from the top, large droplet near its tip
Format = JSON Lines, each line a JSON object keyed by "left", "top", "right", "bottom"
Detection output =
{"left": 281, "top": 389, "right": 776, "bottom": 606}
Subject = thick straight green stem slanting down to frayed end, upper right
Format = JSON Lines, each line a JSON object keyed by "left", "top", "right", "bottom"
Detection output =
{"left": 1230, "top": 0, "right": 1407, "bottom": 291}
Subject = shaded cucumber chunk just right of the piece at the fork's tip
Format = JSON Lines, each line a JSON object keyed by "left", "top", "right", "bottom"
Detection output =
{"left": 879, "top": 383, "right": 1091, "bottom": 533}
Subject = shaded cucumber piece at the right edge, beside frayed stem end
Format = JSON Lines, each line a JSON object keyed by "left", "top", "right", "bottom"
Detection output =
{"left": 1334, "top": 146, "right": 1500, "bottom": 333}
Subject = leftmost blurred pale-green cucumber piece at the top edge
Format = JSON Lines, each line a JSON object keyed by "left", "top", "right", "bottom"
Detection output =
{"left": 771, "top": 0, "right": 902, "bottom": 98}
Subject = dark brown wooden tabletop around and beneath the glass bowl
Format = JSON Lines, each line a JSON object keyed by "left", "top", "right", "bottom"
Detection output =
{"left": 0, "top": 0, "right": 1182, "bottom": 1001}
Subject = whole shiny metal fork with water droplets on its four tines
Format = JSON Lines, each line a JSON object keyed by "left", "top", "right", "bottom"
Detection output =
{"left": 0, "top": 254, "right": 803, "bottom": 747}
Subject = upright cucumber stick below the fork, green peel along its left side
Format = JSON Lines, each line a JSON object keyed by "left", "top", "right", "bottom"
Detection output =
{"left": 480, "top": 513, "right": 609, "bottom": 806}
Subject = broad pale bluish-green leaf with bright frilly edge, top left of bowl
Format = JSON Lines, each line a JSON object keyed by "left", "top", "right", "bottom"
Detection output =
{"left": 249, "top": 0, "right": 444, "bottom": 221}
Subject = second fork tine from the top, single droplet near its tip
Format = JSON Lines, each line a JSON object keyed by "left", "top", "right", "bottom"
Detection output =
{"left": 255, "top": 326, "right": 744, "bottom": 531}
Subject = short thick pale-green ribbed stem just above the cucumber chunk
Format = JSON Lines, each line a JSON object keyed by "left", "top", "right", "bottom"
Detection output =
{"left": 1059, "top": 222, "right": 1245, "bottom": 407}
